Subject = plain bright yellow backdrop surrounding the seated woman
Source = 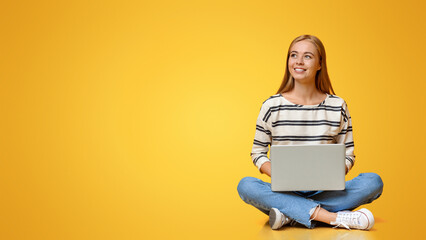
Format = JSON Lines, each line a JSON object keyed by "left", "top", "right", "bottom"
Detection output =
{"left": 0, "top": 0, "right": 426, "bottom": 239}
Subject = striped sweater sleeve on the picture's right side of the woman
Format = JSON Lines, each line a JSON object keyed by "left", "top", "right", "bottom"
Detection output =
{"left": 336, "top": 102, "right": 355, "bottom": 171}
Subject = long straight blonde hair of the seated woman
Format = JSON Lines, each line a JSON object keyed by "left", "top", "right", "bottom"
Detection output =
{"left": 277, "top": 35, "right": 335, "bottom": 95}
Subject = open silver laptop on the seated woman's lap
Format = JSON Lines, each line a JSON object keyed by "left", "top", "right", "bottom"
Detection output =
{"left": 270, "top": 144, "right": 346, "bottom": 192}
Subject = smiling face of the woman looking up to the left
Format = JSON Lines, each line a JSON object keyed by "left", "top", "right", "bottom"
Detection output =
{"left": 288, "top": 40, "right": 321, "bottom": 82}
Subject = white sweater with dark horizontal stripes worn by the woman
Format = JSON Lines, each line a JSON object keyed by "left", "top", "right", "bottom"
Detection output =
{"left": 250, "top": 94, "right": 355, "bottom": 170}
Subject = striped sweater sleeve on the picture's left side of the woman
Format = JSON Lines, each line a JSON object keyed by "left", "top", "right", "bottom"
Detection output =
{"left": 250, "top": 103, "right": 272, "bottom": 171}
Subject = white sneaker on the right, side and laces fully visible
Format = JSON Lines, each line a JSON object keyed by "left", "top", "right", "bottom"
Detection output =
{"left": 330, "top": 208, "right": 374, "bottom": 230}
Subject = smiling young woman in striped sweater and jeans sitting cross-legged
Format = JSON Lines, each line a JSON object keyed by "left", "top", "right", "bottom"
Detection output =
{"left": 238, "top": 35, "right": 383, "bottom": 230}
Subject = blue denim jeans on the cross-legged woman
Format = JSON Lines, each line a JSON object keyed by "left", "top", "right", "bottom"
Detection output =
{"left": 237, "top": 173, "right": 383, "bottom": 228}
